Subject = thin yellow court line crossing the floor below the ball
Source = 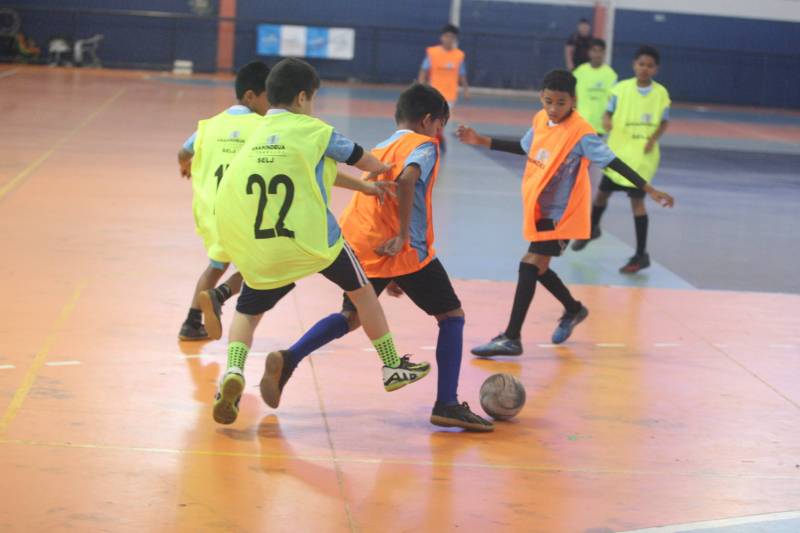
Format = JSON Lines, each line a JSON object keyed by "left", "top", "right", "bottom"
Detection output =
{"left": 0, "top": 438, "right": 797, "bottom": 481}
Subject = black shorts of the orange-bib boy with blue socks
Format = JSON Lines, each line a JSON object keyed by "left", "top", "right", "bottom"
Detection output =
{"left": 342, "top": 259, "right": 461, "bottom": 316}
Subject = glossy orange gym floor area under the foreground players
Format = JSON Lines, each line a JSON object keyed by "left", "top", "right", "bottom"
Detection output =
{"left": 0, "top": 67, "right": 800, "bottom": 533}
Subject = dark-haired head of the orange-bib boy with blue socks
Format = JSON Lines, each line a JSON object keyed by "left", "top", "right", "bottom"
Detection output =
{"left": 394, "top": 83, "right": 450, "bottom": 137}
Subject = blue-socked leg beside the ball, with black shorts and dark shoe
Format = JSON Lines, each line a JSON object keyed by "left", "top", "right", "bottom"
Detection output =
{"left": 395, "top": 259, "right": 494, "bottom": 431}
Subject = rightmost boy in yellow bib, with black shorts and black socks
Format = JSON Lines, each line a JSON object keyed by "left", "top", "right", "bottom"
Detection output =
{"left": 572, "top": 46, "right": 671, "bottom": 274}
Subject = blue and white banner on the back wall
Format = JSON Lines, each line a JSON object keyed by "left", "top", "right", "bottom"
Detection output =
{"left": 256, "top": 24, "right": 356, "bottom": 60}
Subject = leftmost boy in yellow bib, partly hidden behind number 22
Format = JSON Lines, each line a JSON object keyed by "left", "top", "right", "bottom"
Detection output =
{"left": 178, "top": 61, "right": 269, "bottom": 341}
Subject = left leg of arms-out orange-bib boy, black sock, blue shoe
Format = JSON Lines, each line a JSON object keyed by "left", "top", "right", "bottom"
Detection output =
{"left": 472, "top": 246, "right": 552, "bottom": 357}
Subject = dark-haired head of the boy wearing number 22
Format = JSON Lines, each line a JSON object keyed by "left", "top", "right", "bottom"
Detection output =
{"left": 267, "top": 57, "right": 320, "bottom": 115}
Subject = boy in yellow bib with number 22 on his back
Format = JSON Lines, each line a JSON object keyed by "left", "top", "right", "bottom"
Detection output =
{"left": 209, "top": 59, "right": 430, "bottom": 424}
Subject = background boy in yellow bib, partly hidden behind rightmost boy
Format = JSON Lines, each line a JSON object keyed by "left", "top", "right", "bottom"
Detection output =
{"left": 572, "top": 39, "right": 617, "bottom": 135}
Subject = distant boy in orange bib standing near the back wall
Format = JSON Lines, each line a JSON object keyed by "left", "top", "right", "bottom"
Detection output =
{"left": 417, "top": 24, "right": 469, "bottom": 151}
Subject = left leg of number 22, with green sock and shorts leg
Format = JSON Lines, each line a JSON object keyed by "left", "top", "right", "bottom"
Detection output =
{"left": 214, "top": 284, "right": 294, "bottom": 424}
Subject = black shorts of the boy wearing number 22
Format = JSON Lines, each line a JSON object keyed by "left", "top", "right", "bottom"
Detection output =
{"left": 236, "top": 243, "right": 369, "bottom": 316}
